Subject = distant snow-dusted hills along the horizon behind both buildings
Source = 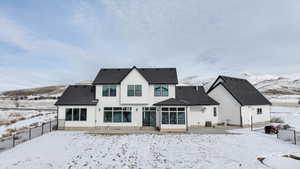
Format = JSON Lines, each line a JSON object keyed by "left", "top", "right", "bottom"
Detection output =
{"left": 2, "top": 73, "right": 300, "bottom": 99}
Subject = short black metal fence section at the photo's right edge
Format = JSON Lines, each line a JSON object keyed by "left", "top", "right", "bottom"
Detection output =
{"left": 277, "top": 128, "right": 300, "bottom": 144}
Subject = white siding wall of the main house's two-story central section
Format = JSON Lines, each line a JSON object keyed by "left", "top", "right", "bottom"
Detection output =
{"left": 91, "top": 69, "right": 175, "bottom": 127}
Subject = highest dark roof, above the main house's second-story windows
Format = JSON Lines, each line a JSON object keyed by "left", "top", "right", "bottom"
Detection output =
{"left": 93, "top": 66, "right": 178, "bottom": 85}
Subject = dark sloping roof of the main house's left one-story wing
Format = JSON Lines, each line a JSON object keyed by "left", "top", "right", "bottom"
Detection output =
{"left": 55, "top": 85, "right": 98, "bottom": 106}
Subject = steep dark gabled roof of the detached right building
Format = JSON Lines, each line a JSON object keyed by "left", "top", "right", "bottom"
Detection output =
{"left": 207, "top": 76, "right": 272, "bottom": 106}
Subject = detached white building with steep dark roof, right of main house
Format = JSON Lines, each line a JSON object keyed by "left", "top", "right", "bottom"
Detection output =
{"left": 207, "top": 76, "right": 271, "bottom": 126}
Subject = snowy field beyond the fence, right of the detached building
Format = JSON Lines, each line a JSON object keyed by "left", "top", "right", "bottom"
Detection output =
{"left": 271, "top": 106, "right": 300, "bottom": 131}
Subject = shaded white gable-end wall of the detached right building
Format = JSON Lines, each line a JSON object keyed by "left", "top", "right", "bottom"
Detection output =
{"left": 208, "top": 85, "right": 241, "bottom": 125}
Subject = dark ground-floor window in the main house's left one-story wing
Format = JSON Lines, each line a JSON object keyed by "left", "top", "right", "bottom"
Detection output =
{"left": 65, "top": 108, "right": 87, "bottom": 121}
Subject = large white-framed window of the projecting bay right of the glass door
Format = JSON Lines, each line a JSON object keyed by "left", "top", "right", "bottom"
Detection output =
{"left": 162, "top": 107, "right": 185, "bottom": 124}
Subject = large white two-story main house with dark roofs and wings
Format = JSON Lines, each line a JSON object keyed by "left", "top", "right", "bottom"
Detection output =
{"left": 55, "top": 66, "right": 219, "bottom": 131}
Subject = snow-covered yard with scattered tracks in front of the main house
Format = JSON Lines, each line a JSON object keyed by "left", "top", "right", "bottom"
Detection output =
{"left": 0, "top": 131, "right": 300, "bottom": 169}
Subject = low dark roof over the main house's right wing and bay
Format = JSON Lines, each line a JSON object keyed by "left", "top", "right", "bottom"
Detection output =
{"left": 154, "top": 86, "right": 219, "bottom": 106}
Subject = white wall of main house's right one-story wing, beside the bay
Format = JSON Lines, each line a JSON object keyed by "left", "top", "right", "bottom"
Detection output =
{"left": 187, "top": 105, "right": 219, "bottom": 127}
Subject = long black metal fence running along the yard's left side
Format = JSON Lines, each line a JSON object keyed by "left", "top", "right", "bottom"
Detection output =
{"left": 0, "top": 119, "right": 57, "bottom": 152}
